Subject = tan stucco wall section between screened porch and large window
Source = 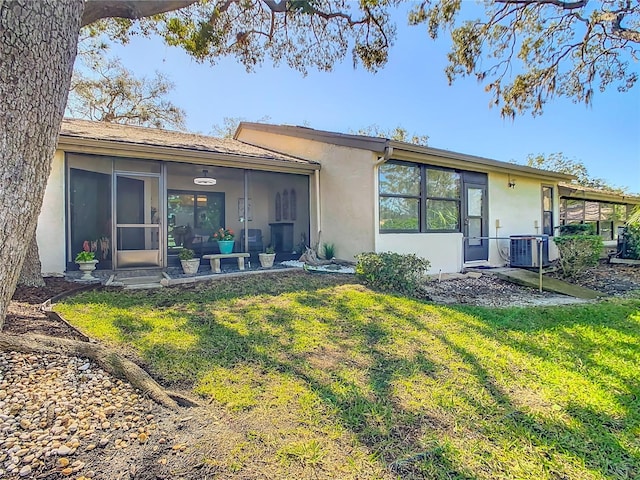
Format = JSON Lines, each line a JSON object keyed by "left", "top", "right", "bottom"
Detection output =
{"left": 239, "top": 129, "right": 377, "bottom": 259}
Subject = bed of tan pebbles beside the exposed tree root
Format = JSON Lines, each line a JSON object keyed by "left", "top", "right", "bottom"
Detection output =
{"left": 0, "top": 352, "right": 159, "bottom": 479}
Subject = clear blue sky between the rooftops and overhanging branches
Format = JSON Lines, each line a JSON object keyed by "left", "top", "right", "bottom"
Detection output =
{"left": 105, "top": 6, "right": 640, "bottom": 193}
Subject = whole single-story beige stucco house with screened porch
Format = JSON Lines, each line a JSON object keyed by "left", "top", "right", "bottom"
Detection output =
{"left": 37, "top": 120, "right": 640, "bottom": 273}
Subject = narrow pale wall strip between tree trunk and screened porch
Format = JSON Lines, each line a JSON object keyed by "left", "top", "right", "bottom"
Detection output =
{"left": 36, "top": 151, "right": 66, "bottom": 275}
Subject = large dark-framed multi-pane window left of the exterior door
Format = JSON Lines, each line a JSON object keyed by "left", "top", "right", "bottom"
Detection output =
{"left": 379, "top": 162, "right": 461, "bottom": 233}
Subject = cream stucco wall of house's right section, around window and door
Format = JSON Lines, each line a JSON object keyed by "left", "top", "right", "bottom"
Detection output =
{"left": 239, "top": 129, "right": 559, "bottom": 273}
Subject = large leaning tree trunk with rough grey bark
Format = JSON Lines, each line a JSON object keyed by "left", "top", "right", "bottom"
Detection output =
{"left": 0, "top": 0, "right": 84, "bottom": 328}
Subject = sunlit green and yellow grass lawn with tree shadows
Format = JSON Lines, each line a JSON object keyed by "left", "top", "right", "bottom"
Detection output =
{"left": 56, "top": 273, "right": 640, "bottom": 480}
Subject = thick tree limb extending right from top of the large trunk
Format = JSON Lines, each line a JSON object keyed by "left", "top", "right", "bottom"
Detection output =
{"left": 82, "top": 0, "right": 197, "bottom": 27}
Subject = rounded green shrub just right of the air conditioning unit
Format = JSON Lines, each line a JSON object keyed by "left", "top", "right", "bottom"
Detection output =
{"left": 553, "top": 235, "right": 604, "bottom": 278}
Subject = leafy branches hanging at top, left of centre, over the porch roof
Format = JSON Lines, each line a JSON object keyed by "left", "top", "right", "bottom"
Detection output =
{"left": 91, "top": 0, "right": 400, "bottom": 73}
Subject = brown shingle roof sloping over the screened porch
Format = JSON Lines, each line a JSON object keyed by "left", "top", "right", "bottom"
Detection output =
{"left": 60, "top": 118, "right": 317, "bottom": 165}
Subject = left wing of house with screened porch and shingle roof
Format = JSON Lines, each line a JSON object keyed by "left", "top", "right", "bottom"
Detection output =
{"left": 37, "top": 119, "right": 320, "bottom": 274}
